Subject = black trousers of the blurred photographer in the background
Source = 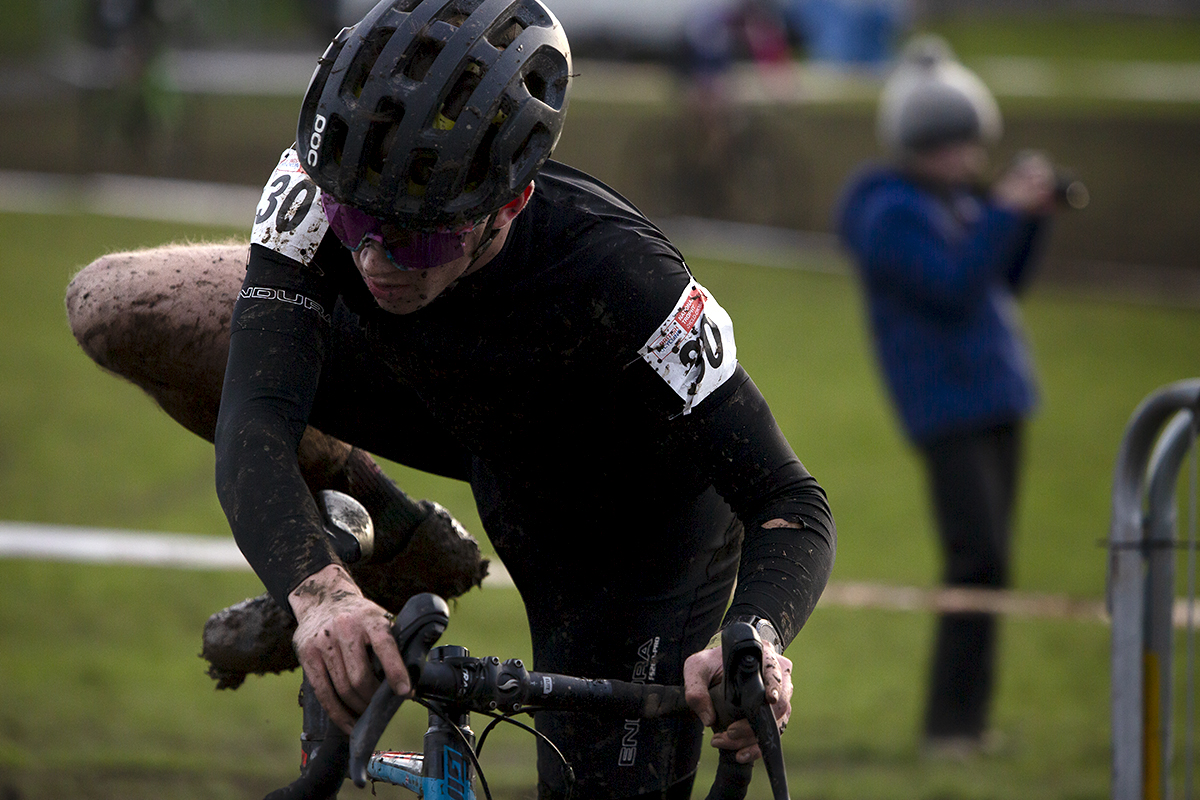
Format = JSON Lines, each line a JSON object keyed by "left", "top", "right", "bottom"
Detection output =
{"left": 922, "top": 422, "right": 1021, "bottom": 736}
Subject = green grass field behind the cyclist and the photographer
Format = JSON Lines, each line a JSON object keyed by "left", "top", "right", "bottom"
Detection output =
{"left": 0, "top": 208, "right": 1200, "bottom": 800}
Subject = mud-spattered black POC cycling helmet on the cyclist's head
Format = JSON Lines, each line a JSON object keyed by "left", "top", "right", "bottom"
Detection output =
{"left": 296, "top": 0, "right": 571, "bottom": 230}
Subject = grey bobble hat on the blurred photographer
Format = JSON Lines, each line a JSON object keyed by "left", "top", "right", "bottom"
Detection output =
{"left": 877, "top": 35, "right": 1001, "bottom": 156}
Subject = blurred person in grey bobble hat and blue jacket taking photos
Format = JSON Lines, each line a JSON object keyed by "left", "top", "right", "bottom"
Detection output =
{"left": 836, "top": 36, "right": 1055, "bottom": 757}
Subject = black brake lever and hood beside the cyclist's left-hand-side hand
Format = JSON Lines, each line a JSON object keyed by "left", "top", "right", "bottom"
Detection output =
{"left": 349, "top": 593, "right": 450, "bottom": 788}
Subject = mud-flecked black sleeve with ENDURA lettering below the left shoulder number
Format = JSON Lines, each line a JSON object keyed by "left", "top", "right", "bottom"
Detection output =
{"left": 216, "top": 245, "right": 336, "bottom": 610}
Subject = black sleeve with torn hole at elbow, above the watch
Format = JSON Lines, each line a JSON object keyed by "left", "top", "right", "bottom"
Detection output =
{"left": 678, "top": 366, "right": 838, "bottom": 646}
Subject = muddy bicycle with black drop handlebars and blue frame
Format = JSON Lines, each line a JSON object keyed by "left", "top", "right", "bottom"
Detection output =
{"left": 258, "top": 493, "right": 788, "bottom": 800}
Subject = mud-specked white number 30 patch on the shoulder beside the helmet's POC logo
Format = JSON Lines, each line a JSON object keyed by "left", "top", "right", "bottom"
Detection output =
{"left": 251, "top": 149, "right": 329, "bottom": 264}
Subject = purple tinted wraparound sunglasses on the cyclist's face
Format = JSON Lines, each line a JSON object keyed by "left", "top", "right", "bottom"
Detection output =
{"left": 320, "top": 192, "right": 482, "bottom": 270}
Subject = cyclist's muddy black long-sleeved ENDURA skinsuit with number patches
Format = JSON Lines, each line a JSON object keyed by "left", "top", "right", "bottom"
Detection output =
{"left": 216, "top": 154, "right": 835, "bottom": 798}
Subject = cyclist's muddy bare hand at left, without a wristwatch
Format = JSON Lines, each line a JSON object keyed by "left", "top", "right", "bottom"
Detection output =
{"left": 288, "top": 564, "right": 412, "bottom": 733}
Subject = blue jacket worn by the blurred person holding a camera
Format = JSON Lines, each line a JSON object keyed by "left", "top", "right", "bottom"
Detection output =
{"left": 835, "top": 167, "right": 1043, "bottom": 444}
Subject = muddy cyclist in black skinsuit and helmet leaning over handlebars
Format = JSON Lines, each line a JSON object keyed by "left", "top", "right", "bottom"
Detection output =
{"left": 68, "top": 0, "right": 835, "bottom": 798}
